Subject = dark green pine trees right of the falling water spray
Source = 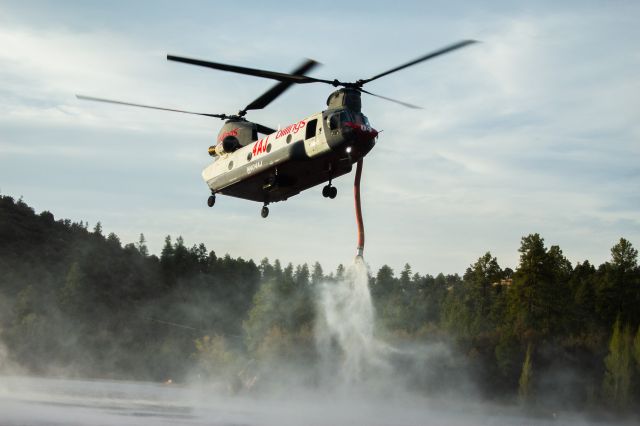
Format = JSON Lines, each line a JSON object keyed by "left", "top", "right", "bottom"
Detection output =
{"left": 382, "top": 234, "right": 640, "bottom": 410}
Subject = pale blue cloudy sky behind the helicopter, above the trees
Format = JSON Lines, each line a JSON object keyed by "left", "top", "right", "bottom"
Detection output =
{"left": 0, "top": 0, "right": 640, "bottom": 274}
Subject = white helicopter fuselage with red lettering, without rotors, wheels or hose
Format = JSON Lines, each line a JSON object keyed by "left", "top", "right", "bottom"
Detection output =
{"left": 202, "top": 109, "right": 378, "bottom": 203}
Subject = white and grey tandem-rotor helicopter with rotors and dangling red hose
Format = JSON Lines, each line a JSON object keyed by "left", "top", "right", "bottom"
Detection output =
{"left": 76, "top": 40, "right": 476, "bottom": 220}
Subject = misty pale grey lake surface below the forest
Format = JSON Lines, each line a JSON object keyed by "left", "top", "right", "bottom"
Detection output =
{"left": 0, "top": 376, "right": 632, "bottom": 426}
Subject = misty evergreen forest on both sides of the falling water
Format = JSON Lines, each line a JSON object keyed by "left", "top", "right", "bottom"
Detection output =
{"left": 0, "top": 196, "right": 640, "bottom": 414}
